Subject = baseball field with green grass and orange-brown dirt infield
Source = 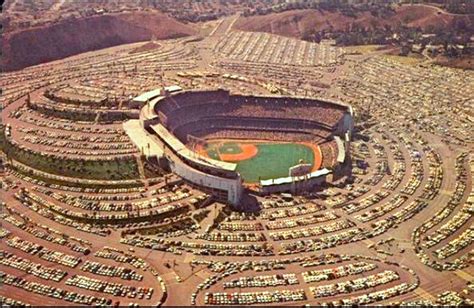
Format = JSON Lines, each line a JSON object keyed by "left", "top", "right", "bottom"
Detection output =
{"left": 196, "top": 140, "right": 321, "bottom": 183}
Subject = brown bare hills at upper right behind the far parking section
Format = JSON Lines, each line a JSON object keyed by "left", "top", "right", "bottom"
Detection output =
{"left": 234, "top": 5, "right": 474, "bottom": 38}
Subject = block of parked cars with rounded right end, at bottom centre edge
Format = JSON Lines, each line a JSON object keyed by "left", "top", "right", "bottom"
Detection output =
{"left": 191, "top": 254, "right": 419, "bottom": 305}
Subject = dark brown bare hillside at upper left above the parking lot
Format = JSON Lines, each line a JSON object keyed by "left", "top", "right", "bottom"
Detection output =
{"left": 2, "top": 12, "right": 196, "bottom": 71}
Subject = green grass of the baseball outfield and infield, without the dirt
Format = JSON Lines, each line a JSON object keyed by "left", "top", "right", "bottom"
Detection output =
{"left": 206, "top": 142, "right": 314, "bottom": 183}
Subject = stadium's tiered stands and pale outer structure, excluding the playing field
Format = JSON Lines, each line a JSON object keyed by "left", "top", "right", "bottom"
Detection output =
{"left": 131, "top": 87, "right": 354, "bottom": 208}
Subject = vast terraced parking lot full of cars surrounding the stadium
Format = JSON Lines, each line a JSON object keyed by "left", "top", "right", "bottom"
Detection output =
{"left": 0, "top": 11, "right": 474, "bottom": 306}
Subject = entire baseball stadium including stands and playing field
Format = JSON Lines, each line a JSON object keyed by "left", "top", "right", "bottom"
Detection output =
{"left": 132, "top": 86, "right": 353, "bottom": 208}
